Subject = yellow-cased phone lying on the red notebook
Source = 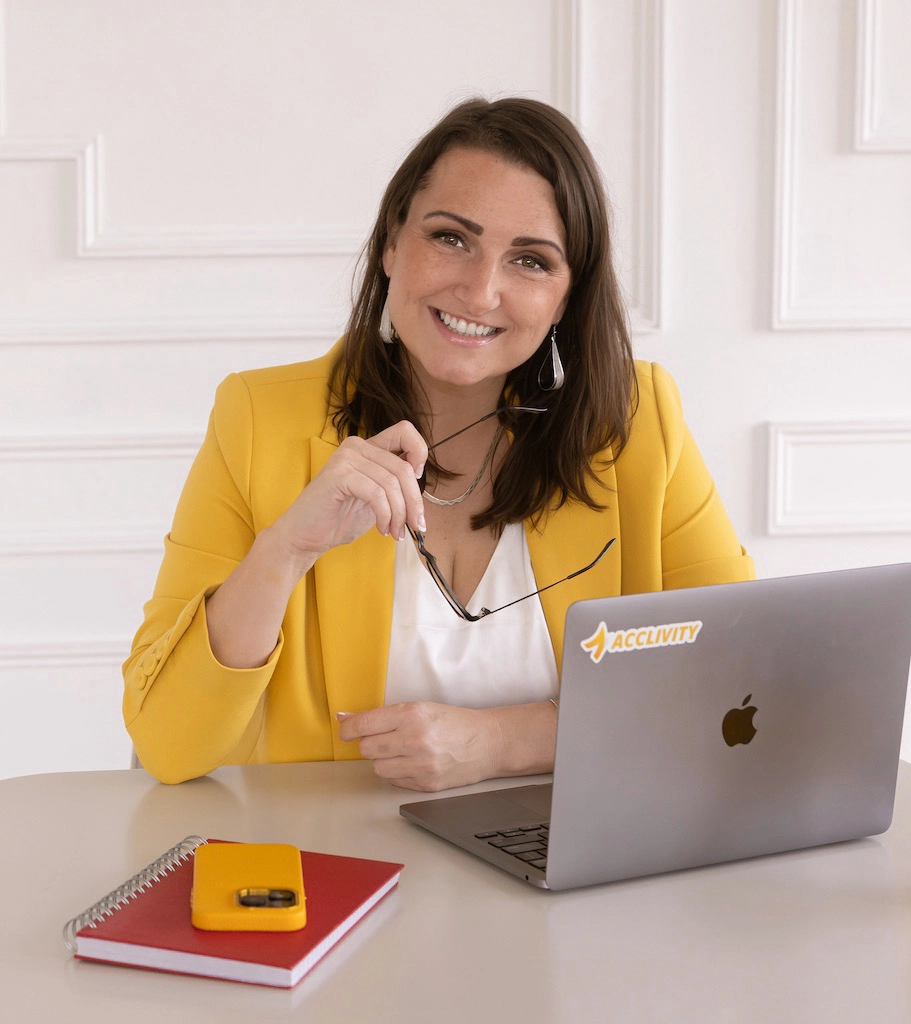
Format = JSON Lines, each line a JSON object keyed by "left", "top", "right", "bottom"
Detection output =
{"left": 190, "top": 843, "right": 307, "bottom": 932}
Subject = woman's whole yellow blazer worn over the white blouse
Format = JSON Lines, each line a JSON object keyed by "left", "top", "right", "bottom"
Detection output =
{"left": 123, "top": 352, "right": 753, "bottom": 782}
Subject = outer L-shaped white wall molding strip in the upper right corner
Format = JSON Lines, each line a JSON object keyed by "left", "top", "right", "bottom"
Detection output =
{"left": 772, "top": 0, "right": 911, "bottom": 331}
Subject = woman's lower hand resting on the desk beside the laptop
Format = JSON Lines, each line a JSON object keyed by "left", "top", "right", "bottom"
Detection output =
{"left": 338, "top": 700, "right": 505, "bottom": 793}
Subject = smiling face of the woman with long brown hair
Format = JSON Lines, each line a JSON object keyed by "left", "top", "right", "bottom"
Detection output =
{"left": 383, "top": 148, "right": 571, "bottom": 400}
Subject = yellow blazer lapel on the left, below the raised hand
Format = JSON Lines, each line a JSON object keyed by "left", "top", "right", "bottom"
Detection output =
{"left": 310, "top": 424, "right": 395, "bottom": 760}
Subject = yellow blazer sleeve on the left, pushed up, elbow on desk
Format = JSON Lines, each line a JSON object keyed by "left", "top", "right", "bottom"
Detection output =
{"left": 123, "top": 374, "right": 284, "bottom": 782}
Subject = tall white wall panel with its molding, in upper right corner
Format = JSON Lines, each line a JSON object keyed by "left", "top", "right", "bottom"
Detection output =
{"left": 773, "top": 0, "right": 911, "bottom": 330}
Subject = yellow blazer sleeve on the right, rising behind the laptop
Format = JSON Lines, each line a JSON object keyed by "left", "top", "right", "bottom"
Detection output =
{"left": 651, "top": 365, "right": 755, "bottom": 590}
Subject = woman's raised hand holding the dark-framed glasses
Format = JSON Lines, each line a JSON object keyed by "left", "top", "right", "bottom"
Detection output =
{"left": 272, "top": 420, "right": 427, "bottom": 574}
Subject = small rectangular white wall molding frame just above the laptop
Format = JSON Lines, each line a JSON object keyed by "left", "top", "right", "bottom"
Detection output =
{"left": 767, "top": 420, "right": 911, "bottom": 537}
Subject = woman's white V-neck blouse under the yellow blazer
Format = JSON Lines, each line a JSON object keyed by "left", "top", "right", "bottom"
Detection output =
{"left": 386, "top": 523, "right": 558, "bottom": 708}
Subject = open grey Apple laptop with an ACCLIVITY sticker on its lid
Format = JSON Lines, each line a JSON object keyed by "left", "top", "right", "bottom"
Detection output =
{"left": 400, "top": 563, "right": 911, "bottom": 890}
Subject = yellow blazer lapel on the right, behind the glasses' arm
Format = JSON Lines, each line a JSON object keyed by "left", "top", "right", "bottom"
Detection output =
{"left": 525, "top": 466, "right": 621, "bottom": 671}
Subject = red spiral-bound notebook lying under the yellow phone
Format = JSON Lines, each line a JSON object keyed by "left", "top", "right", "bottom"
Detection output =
{"left": 63, "top": 836, "right": 402, "bottom": 988}
